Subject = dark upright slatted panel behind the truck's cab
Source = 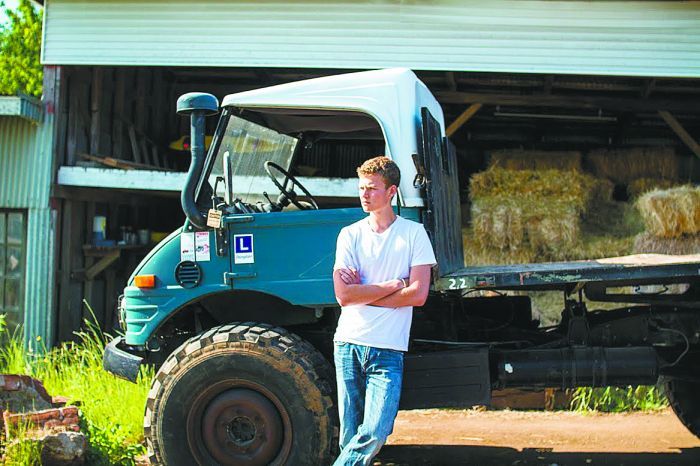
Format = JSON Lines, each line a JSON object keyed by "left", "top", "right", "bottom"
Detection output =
{"left": 415, "top": 107, "right": 464, "bottom": 275}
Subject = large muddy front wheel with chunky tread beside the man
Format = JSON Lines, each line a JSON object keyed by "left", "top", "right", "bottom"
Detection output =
{"left": 144, "top": 322, "right": 338, "bottom": 466}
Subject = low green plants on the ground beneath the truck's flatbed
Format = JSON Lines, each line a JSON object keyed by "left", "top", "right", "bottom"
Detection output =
{"left": 571, "top": 385, "right": 668, "bottom": 413}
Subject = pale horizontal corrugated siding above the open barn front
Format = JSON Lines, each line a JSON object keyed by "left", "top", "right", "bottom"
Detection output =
{"left": 43, "top": 0, "right": 700, "bottom": 77}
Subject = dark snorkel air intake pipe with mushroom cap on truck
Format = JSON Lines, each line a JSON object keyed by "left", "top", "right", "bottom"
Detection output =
{"left": 176, "top": 92, "right": 219, "bottom": 229}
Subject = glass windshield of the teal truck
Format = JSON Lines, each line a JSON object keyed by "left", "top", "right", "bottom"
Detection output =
{"left": 209, "top": 115, "right": 299, "bottom": 202}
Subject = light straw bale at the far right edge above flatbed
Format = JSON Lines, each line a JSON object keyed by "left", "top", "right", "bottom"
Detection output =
{"left": 635, "top": 186, "right": 700, "bottom": 254}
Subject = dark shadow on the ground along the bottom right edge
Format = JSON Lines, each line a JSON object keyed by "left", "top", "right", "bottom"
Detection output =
{"left": 375, "top": 445, "right": 700, "bottom": 466}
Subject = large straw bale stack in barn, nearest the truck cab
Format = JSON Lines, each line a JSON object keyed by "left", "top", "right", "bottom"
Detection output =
{"left": 465, "top": 168, "right": 612, "bottom": 259}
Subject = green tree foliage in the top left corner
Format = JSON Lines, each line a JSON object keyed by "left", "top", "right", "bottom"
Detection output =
{"left": 0, "top": 0, "right": 43, "bottom": 97}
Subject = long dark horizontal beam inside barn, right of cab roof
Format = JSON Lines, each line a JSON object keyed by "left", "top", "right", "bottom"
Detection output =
{"left": 434, "top": 91, "right": 700, "bottom": 113}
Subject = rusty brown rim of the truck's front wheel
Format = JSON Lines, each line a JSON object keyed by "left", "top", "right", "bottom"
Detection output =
{"left": 187, "top": 381, "right": 291, "bottom": 466}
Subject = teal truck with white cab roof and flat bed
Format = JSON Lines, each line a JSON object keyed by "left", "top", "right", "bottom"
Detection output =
{"left": 104, "top": 69, "right": 700, "bottom": 466}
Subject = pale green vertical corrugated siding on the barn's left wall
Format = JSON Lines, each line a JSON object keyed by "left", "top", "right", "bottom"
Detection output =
{"left": 0, "top": 112, "right": 55, "bottom": 345}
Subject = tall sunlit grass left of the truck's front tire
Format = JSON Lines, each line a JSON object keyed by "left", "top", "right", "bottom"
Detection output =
{"left": 0, "top": 312, "right": 153, "bottom": 466}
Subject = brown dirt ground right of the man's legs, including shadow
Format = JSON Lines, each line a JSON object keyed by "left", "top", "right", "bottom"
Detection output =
{"left": 375, "top": 410, "right": 700, "bottom": 466}
